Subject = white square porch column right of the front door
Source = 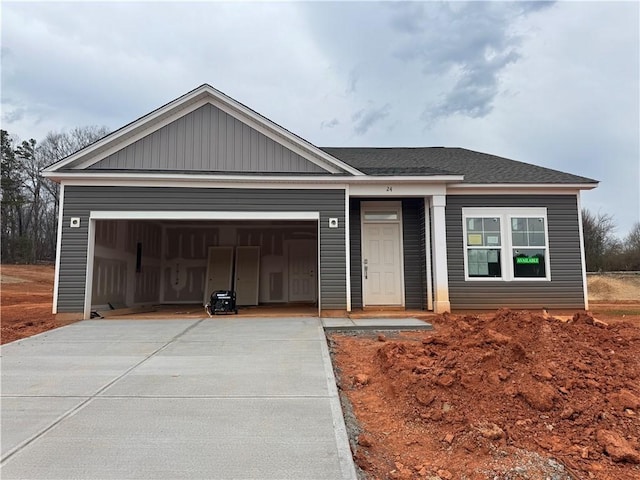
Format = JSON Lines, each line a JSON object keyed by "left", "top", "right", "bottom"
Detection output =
{"left": 431, "top": 195, "right": 451, "bottom": 313}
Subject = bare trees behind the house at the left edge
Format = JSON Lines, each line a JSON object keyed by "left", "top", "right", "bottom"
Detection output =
{"left": 0, "top": 126, "right": 109, "bottom": 263}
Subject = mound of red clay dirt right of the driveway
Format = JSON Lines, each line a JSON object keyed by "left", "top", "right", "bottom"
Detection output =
{"left": 331, "top": 309, "right": 640, "bottom": 480}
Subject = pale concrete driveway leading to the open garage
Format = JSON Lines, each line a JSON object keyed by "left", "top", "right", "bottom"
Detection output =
{"left": 0, "top": 317, "right": 356, "bottom": 480}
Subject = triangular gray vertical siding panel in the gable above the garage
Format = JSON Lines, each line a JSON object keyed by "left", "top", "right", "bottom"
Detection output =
{"left": 89, "top": 104, "right": 327, "bottom": 173}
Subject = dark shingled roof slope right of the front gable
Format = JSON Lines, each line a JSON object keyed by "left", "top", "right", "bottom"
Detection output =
{"left": 321, "top": 147, "right": 598, "bottom": 184}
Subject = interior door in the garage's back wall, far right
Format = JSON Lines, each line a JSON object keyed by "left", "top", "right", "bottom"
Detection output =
{"left": 288, "top": 240, "right": 317, "bottom": 302}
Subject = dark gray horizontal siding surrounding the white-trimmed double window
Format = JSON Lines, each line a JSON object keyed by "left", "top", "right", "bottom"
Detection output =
{"left": 446, "top": 195, "right": 584, "bottom": 310}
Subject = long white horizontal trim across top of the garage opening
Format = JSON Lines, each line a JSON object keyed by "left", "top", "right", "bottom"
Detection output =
{"left": 89, "top": 210, "right": 320, "bottom": 221}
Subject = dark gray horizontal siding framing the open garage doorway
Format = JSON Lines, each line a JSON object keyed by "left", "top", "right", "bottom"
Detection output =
{"left": 58, "top": 186, "right": 346, "bottom": 312}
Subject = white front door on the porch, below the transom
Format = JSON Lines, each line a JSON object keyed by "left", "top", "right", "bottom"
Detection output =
{"left": 362, "top": 223, "right": 403, "bottom": 306}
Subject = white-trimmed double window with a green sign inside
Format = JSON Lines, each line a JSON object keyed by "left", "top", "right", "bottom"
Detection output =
{"left": 462, "top": 207, "right": 551, "bottom": 281}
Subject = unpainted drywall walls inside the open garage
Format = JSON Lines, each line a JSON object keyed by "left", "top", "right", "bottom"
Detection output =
{"left": 92, "top": 220, "right": 317, "bottom": 308}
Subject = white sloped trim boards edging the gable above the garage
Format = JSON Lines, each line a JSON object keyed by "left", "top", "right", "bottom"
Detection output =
{"left": 44, "top": 84, "right": 362, "bottom": 176}
